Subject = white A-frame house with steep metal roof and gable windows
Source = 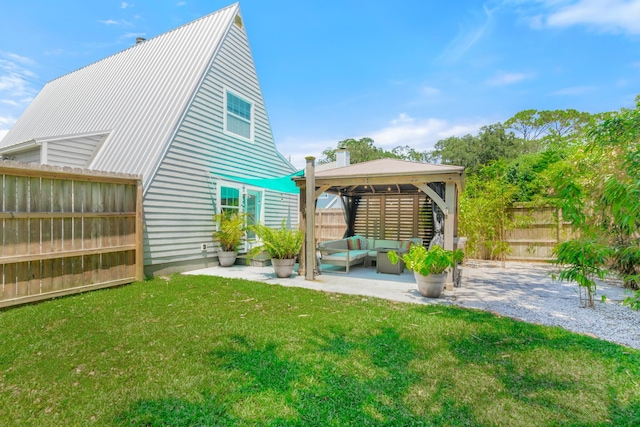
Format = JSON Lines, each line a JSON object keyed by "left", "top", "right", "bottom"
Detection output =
{"left": 0, "top": 3, "right": 298, "bottom": 274}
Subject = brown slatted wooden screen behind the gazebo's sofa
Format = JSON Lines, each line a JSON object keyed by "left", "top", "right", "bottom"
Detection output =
{"left": 354, "top": 194, "right": 433, "bottom": 246}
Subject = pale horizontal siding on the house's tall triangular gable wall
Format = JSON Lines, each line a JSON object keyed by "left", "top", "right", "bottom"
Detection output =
{"left": 144, "top": 18, "right": 298, "bottom": 265}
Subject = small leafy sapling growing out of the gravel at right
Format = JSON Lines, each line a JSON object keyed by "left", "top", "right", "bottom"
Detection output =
{"left": 553, "top": 238, "right": 612, "bottom": 307}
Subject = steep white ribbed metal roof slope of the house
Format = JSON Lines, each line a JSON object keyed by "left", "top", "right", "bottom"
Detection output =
{"left": 0, "top": 3, "right": 240, "bottom": 186}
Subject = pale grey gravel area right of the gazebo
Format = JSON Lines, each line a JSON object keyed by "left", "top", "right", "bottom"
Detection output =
{"left": 452, "top": 261, "right": 640, "bottom": 349}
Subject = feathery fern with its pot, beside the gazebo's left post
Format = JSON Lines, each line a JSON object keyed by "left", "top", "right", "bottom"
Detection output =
{"left": 248, "top": 219, "right": 303, "bottom": 278}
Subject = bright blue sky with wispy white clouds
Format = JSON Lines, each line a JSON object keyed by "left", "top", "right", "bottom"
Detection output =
{"left": 0, "top": 0, "right": 640, "bottom": 166}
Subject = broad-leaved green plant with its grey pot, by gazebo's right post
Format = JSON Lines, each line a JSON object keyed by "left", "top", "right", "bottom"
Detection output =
{"left": 388, "top": 245, "right": 464, "bottom": 298}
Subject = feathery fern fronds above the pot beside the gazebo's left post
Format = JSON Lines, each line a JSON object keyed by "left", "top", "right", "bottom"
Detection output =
{"left": 248, "top": 219, "right": 304, "bottom": 259}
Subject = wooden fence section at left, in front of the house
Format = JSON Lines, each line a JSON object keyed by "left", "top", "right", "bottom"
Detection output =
{"left": 0, "top": 161, "right": 144, "bottom": 307}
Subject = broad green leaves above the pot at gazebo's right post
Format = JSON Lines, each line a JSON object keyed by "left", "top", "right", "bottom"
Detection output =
{"left": 387, "top": 245, "right": 464, "bottom": 276}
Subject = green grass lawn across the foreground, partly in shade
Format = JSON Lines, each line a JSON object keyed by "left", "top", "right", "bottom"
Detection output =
{"left": 0, "top": 276, "right": 640, "bottom": 427}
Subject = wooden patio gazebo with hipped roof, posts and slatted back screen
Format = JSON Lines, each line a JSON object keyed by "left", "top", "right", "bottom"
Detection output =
{"left": 292, "top": 157, "right": 464, "bottom": 281}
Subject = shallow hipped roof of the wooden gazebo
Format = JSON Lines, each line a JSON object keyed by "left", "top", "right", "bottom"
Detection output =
{"left": 294, "top": 159, "right": 464, "bottom": 196}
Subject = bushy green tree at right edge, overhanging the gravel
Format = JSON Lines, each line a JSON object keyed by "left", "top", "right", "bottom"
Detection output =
{"left": 553, "top": 97, "right": 640, "bottom": 298}
